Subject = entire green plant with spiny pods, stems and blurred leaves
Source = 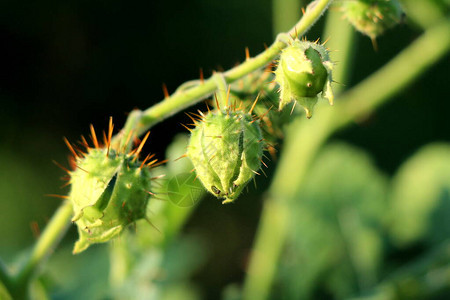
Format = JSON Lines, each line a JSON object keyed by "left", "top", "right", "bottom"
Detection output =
{"left": 0, "top": 0, "right": 450, "bottom": 299}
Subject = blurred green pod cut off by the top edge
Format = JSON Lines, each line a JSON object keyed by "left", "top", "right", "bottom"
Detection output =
{"left": 341, "top": 0, "right": 402, "bottom": 41}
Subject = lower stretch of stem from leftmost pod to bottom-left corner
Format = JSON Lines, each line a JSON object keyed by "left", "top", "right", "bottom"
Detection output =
{"left": 13, "top": 201, "right": 73, "bottom": 299}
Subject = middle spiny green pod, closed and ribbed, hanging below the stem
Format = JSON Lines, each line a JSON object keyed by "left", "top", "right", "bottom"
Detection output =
{"left": 187, "top": 111, "right": 263, "bottom": 203}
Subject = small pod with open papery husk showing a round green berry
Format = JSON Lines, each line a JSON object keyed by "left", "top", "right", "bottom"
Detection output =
{"left": 275, "top": 39, "right": 334, "bottom": 118}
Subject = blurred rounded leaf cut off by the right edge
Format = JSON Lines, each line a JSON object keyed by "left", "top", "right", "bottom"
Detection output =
{"left": 389, "top": 144, "right": 450, "bottom": 246}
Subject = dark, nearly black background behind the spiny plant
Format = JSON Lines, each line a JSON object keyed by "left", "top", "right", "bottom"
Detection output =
{"left": 0, "top": 0, "right": 450, "bottom": 295}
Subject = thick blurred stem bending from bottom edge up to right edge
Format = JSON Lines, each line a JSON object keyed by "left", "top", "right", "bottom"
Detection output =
{"left": 243, "top": 20, "right": 450, "bottom": 299}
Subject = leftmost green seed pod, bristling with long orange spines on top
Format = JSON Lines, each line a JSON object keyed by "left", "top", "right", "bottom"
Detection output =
{"left": 68, "top": 123, "right": 156, "bottom": 254}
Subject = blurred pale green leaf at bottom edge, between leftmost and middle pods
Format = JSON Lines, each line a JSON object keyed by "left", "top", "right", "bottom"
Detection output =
{"left": 111, "top": 235, "right": 206, "bottom": 299}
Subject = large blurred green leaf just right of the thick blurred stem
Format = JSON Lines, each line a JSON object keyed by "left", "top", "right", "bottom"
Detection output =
{"left": 279, "top": 144, "right": 386, "bottom": 299}
